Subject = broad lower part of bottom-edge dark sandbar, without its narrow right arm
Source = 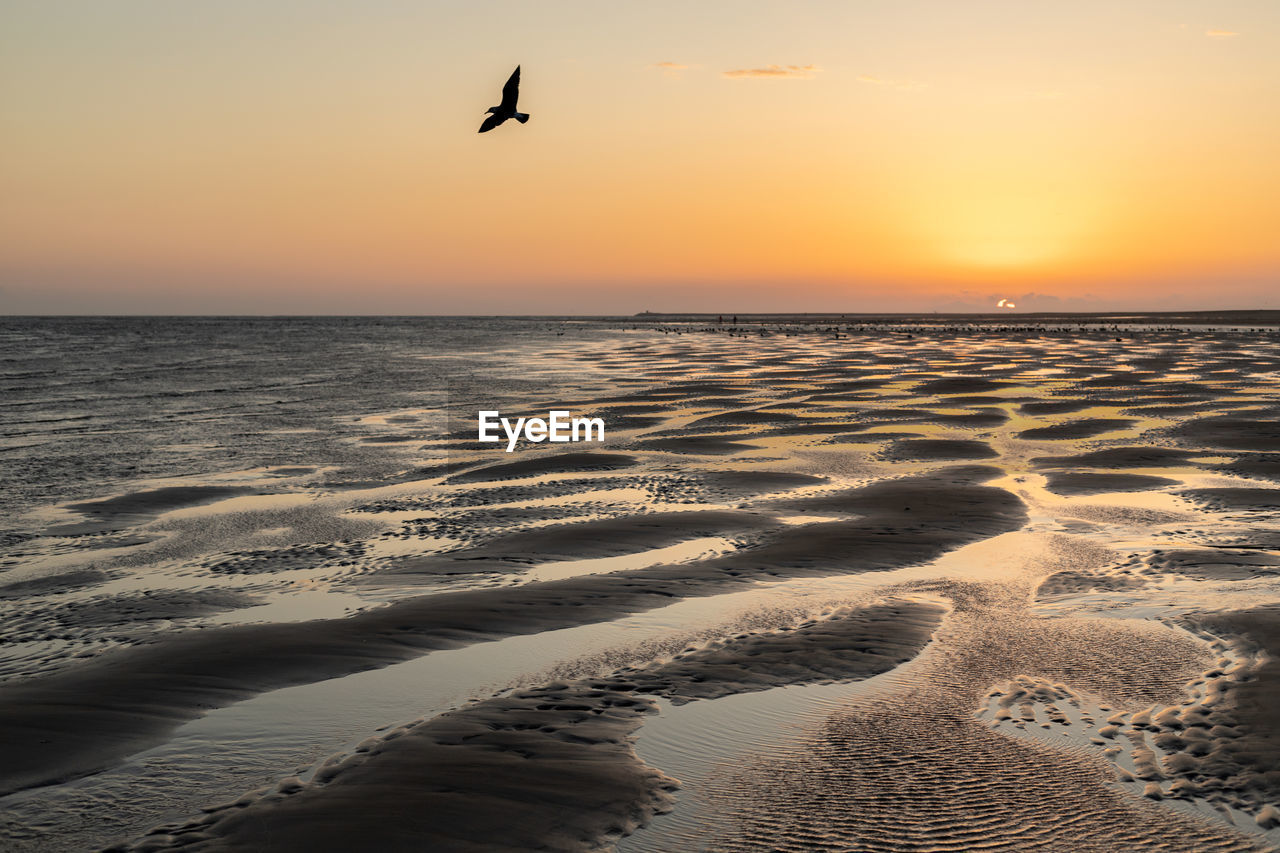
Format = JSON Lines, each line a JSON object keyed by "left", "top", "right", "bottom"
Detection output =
{"left": 119, "top": 684, "right": 677, "bottom": 853}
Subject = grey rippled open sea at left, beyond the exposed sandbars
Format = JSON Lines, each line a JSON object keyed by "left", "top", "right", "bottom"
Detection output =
{"left": 0, "top": 318, "right": 604, "bottom": 527}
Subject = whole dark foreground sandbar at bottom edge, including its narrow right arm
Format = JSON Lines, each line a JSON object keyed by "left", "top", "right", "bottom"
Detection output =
{"left": 123, "top": 602, "right": 945, "bottom": 850}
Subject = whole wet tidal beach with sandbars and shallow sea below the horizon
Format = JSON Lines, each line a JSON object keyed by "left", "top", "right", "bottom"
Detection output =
{"left": 0, "top": 314, "right": 1280, "bottom": 853}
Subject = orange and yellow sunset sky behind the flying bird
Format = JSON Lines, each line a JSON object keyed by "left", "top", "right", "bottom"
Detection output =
{"left": 0, "top": 0, "right": 1280, "bottom": 314}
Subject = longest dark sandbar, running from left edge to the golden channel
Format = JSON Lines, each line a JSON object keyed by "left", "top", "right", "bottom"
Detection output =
{"left": 0, "top": 466, "right": 1027, "bottom": 793}
